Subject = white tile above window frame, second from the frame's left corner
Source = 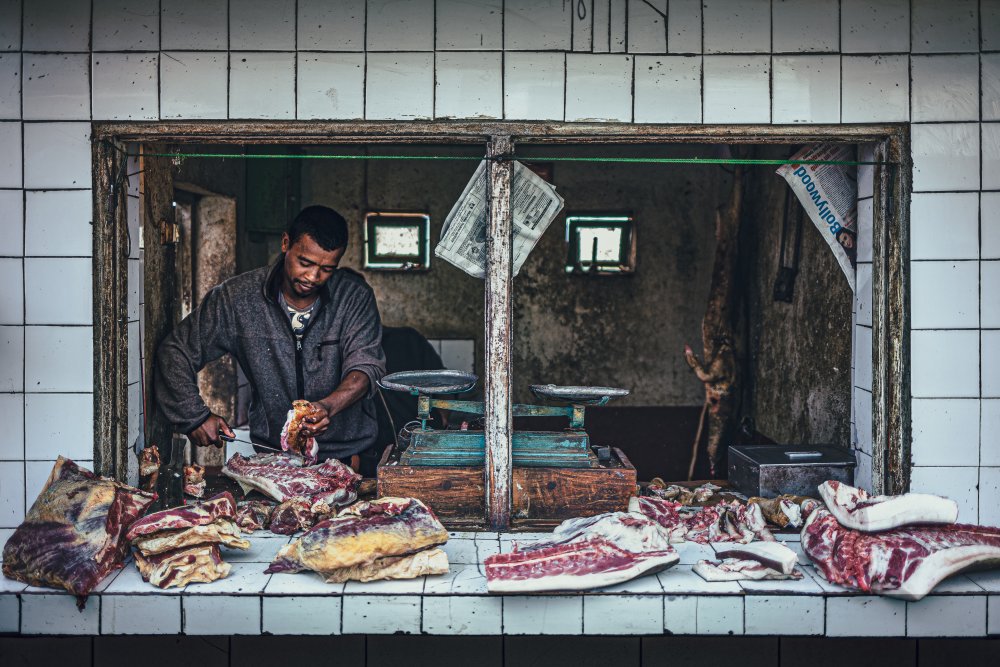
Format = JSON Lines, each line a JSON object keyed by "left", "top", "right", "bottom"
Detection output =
{"left": 160, "top": 51, "right": 229, "bottom": 118}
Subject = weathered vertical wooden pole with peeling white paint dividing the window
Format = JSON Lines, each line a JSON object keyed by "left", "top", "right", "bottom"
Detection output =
{"left": 484, "top": 135, "right": 514, "bottom": 531}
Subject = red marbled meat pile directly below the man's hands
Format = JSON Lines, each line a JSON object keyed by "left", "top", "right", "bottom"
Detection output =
{"left": 222, "top": 454, "right": 361, "bottom": 535}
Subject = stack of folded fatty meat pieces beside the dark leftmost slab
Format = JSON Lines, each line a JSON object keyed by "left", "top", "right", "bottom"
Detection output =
{"left": 126, "top": 492, "right": 250, "bottom": 588}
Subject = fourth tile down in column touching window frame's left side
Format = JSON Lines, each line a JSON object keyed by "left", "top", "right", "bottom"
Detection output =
{"left": 24, "top": 326, "right": 94, "bottom": 392}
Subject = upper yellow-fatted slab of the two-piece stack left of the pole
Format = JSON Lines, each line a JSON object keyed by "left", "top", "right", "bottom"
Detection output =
{"left": 266, "top": 498, "right": 448, "bottom": 573}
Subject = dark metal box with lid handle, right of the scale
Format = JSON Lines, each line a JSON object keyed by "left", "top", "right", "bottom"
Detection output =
{"left": 729, "top": 445, "right": 856, "bottom": 498}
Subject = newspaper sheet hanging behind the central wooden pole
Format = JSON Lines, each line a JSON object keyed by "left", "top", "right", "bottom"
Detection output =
{"left": 434, "top": 160, "right": 563, "bottom": 278}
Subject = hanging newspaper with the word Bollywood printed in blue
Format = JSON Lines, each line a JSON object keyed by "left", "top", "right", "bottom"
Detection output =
{"left": 777, "top": 144, "right": 858, "bottom": 291}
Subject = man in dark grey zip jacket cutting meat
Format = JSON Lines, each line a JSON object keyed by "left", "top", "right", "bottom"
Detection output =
{"left": 154, "top": 206, "right": 385, "bottom": 467}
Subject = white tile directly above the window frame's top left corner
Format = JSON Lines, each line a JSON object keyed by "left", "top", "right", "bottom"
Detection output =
{"left": 91, "top": 53, "right": 160, "bottom": 120}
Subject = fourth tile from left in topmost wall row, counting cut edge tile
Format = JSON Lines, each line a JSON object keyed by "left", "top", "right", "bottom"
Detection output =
{"left": 160, "top": 0, "right": 229, "bottom": 51}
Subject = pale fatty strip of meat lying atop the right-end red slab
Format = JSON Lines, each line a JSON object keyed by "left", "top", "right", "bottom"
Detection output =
{"left": 819, "top": 480, "right": 958, "bottom": 532}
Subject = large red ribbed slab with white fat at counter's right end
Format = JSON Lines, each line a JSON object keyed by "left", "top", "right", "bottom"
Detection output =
{"left": 802, "top": 508, "right": 1000, "bottom": 600}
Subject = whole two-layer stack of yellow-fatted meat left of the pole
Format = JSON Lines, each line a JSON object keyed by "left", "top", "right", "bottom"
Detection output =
{"left": 266, "top": 498, "right": 448, "bottom": 583}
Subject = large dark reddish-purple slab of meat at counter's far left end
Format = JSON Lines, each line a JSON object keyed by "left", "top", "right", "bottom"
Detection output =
{"left": 3, "top": 456, "right": 155, "bottom": 606}
